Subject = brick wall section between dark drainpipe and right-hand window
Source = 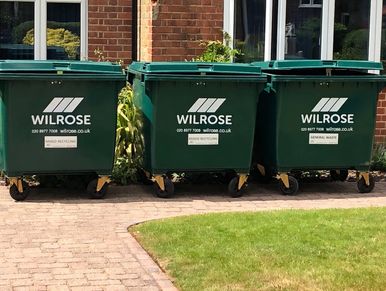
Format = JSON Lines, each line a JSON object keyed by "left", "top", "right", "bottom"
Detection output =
{"left": 139, "top": 0, "right": 224, "bottom": 61}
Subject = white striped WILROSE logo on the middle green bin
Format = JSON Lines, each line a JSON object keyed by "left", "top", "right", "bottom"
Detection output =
{"left": 177, "top": 98, "right": 232, "bottom": 125}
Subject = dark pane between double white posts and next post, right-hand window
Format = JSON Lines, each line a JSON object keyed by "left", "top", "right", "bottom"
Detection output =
{"left": 285, "top": 0, "right": 322, "bottom": 59}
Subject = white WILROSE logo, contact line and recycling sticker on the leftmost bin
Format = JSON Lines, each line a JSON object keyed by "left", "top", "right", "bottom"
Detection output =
{"left": 31, "top": 97, "right": 92, "bottom": 148}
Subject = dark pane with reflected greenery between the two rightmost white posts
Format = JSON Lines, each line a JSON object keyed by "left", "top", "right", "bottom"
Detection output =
{"left": 334, "top": 0, "right": 370, "bottom": 60}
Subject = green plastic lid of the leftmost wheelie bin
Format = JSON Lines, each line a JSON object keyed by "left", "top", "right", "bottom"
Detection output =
{"left": 0, "top": 60, "right": 123, "bottom": 75}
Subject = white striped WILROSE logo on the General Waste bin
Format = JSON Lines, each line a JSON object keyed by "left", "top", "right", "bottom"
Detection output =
{"left": 301, "top": 98, "right": 354, "bottom": 124}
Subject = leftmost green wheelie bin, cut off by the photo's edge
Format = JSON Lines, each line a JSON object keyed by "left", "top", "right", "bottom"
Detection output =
{"left": 0, "top": 60, "right": 126, "bottom": 200}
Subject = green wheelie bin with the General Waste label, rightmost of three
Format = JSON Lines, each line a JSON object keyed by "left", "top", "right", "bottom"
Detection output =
{"left": 253, "top": 60, "right": 385, "bottom": 195}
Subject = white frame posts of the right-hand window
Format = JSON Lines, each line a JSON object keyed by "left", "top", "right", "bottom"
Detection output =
{"left": 224, "top": 0, "right": 383, "bottom": 62}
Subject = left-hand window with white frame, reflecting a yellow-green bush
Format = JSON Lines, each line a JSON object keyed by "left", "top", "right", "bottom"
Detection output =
{"left": 0, "top": 0, "right": 87, "bottom": 60}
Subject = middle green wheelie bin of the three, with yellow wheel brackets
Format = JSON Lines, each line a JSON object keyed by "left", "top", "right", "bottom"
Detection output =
{"left": 129, "top": 62, "right": 266, "bottom": 198}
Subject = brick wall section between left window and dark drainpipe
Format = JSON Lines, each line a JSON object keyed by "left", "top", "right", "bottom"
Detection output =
{"left": 88, "top": 0, "right": 132, "bottom": 64}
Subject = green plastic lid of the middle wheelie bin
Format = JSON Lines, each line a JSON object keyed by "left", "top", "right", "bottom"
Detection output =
{"left": 129, "top": 62, "right": 261, "bottom": 75}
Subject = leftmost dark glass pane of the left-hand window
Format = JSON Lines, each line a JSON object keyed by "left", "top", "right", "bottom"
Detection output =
{"left": 0, "top": 2, "right": 34, "bottom": 60}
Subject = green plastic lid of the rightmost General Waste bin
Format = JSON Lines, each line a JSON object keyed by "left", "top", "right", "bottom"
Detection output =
{"left": 252, "top": 60, "right": 383, "bottom": 71}
